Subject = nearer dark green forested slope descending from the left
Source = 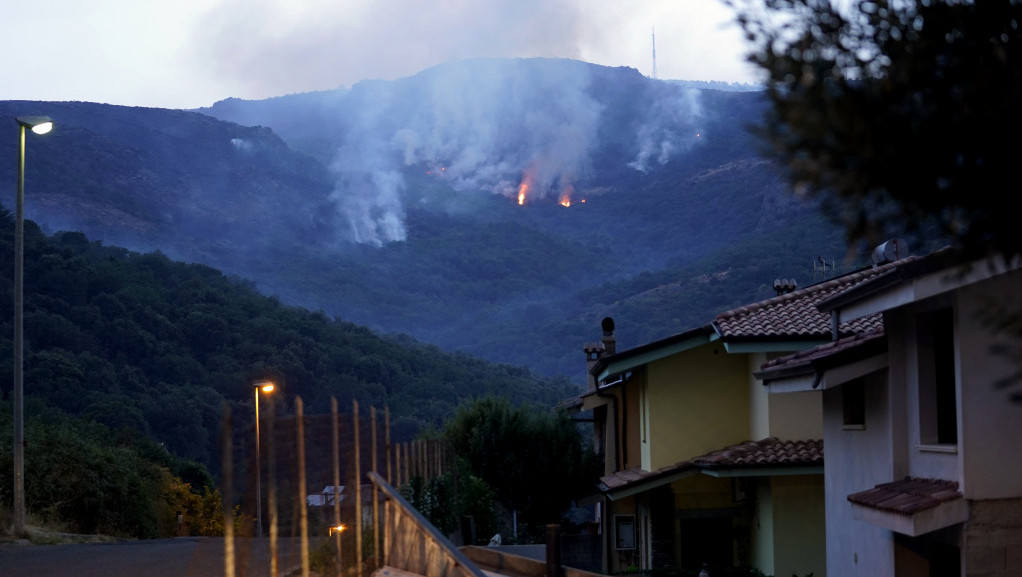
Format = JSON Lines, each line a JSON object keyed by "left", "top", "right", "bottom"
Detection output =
{"left": 0, "top": 211, "right": 577, "bottom": 471}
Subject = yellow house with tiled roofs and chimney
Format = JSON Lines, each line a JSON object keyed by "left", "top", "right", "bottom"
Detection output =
{"left": 578, "top": 257, "right": 919, "bottom": 577}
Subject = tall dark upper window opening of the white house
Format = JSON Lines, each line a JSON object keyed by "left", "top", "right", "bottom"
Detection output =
{"left": 916, "top": 308, "right": 958, "bottom": 444}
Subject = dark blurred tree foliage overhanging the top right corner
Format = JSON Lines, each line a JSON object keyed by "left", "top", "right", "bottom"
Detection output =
{"left": 725, "top": 0, "right": 1022, "bottom": 254}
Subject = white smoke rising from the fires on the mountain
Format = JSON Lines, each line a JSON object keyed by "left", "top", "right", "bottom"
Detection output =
{"left": 324, "top": 59, "right": 700, "bottom": 246}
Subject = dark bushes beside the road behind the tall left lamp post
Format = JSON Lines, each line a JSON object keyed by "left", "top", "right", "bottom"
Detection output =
{"left": 0, "top": 402, "right": 209, "bottom": 538}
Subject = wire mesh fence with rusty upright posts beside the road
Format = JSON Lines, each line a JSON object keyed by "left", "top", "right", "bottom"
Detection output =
{"left": 220, "top": 397, "right": 453, "bottom": 577}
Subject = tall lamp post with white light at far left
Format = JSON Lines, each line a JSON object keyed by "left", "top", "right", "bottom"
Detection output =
{"left": 13, "top": 116, "right": 53, "bottom": 536}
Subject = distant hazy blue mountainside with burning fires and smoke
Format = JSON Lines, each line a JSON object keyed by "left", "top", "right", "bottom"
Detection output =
{"left": 0, "top": 58, "right": 871, "bottom": 384}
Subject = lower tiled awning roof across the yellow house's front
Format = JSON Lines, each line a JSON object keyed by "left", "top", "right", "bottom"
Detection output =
{"left": 600, "top": 437, "right": 824, "bottom": 492}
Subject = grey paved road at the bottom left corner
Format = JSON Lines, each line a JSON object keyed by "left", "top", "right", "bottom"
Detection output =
{"left": 0, "top": 537, "right": 301, "bottom": 577}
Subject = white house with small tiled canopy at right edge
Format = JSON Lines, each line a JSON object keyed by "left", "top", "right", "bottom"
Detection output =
{"left": 756, "top": 249, "right": 1022, "bottom": 577}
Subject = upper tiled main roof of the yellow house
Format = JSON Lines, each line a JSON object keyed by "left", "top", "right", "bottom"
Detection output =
{"left": 713, "top": 256, "right": 915, "bottom": 340}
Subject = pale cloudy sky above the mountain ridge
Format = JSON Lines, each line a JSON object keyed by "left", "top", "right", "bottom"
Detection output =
{"left": 0, "top": 0, "right": 757, "bottom": 108}
